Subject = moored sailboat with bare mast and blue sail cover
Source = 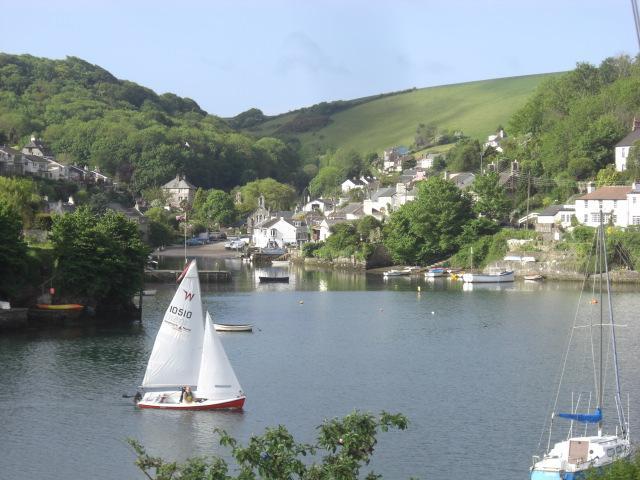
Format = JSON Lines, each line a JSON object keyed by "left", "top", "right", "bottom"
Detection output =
{"left": 530, "top": 218, "right": 631, "bottom": 480}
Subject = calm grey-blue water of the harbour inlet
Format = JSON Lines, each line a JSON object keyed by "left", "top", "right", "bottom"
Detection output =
{"left": 0, "top": 261, "right": 640, "bottom": 480}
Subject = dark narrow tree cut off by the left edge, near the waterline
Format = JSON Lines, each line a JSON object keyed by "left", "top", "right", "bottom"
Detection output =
{"left": 0, "top": 198, "right": 27, "bottom": 299}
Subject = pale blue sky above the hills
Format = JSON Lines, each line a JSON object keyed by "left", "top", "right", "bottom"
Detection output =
{"left": 0, "top": 0, "right": 638, "bottom": 117}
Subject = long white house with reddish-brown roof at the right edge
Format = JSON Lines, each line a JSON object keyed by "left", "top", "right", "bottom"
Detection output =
{"left": 575, "top": 182, "right": 640, "bottom": 227}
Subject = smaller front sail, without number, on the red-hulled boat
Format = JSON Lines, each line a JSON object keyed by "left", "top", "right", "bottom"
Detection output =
{"left": 196, "top": 312, "right": 243, "bottom": 400}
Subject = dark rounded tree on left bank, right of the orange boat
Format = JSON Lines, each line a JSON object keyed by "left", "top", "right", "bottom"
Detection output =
{"left": 50, "top": 207, "right": 148, "bottom": 306}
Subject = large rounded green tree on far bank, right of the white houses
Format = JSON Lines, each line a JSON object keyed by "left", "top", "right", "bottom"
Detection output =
{"left": 384, "top": 177, "right": 473, "bottom": 264}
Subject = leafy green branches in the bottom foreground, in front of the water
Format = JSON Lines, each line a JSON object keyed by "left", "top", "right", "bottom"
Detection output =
{"left": 129, "top": 411, "right": 408, "bottom": 480}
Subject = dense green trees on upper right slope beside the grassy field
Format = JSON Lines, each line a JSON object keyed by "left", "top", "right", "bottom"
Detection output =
{"left": 505, "top": 56, "right": 640, "bottom": 179}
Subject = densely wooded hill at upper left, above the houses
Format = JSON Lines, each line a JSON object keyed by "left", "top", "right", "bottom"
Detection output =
{"left": 0, "top": 54, "right": 301, "bottom": 192}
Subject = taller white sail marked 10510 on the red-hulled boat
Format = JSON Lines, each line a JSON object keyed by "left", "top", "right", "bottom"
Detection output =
{"left": 142, "top": 260, "right": 204, "bottom": 388}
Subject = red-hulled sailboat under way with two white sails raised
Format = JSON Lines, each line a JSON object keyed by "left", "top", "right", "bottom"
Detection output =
{"left": 138, "top": 260, "right": 246, "bottom": 410}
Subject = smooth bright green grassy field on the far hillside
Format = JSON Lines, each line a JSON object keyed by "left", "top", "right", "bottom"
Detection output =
{"left": 249, "top": 74, "right": 557, "bottom": 156}
